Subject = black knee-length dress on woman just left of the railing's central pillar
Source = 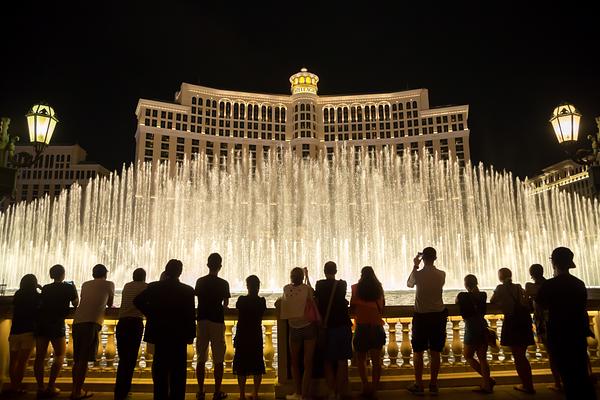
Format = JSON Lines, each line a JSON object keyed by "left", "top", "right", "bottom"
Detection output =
{"left": 233, "top": 295, "right": 267, "bottom": 376}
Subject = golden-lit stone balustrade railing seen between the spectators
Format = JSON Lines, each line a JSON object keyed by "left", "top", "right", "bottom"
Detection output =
{"left": 0, "top": 297, "right": 600, "bottom": 394}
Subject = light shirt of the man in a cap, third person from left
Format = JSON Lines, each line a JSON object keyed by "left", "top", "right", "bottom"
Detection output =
{"left": 73, "top": 278, "right": 115, "bottom": 325}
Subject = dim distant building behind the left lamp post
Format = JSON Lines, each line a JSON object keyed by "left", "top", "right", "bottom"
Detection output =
{"left": 14, "top": 144, "right": 109, "bottom": 201}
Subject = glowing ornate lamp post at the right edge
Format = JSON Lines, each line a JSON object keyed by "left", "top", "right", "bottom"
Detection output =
{"left": 550, "top": 103, "right": 600, "bottom": 194}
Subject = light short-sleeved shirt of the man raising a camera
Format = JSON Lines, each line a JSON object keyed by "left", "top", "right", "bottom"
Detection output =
{"left": 407, "top": 267, "right": 446, "bottom": 313}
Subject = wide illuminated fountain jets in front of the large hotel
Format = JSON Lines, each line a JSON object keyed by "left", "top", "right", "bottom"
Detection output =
{"left": 0, "top": 150, "right": 600, "bottom": 292}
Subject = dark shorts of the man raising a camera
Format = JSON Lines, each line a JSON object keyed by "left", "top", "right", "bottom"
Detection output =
{"left": 410, "top": 310, "right": 448, "bottom": 353}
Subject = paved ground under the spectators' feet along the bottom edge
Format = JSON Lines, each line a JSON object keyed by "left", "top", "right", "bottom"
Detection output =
{"left": 4, "top": 384, "right": 600, "bottom": 400}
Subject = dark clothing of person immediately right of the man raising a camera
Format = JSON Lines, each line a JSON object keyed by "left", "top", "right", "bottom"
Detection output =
{"left": 457, "top": 292, "right": 487, "bottom": 346}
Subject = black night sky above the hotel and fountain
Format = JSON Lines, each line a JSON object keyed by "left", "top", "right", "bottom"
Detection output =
{"left": 0, "top": 1, "right": 600, "bottom": 177}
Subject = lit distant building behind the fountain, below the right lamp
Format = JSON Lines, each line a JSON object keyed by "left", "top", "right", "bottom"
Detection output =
{"left": 528, "top": 160, "right": 600, "bottom": 198}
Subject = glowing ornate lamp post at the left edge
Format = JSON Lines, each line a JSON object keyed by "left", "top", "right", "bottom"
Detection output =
{"left": 0, "top": 103, "right": 58, "bottom": 200}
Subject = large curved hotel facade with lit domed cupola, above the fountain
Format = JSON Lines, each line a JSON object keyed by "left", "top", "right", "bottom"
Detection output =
{"left": 135, "top": 68, "right": 470, "bottom": 166}
